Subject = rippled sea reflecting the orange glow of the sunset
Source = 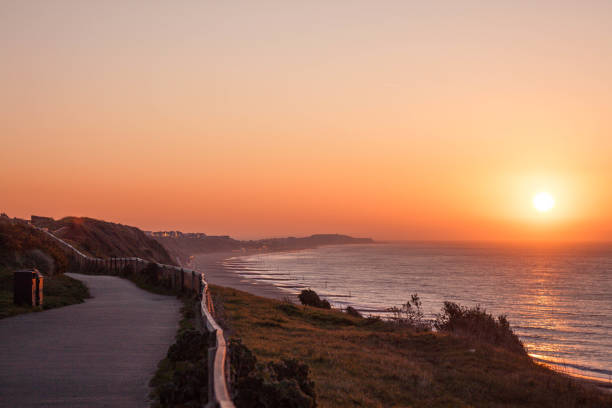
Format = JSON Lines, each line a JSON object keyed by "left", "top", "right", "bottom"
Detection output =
{"left": 223, "top": 242, "right": 612, "bottom": 382}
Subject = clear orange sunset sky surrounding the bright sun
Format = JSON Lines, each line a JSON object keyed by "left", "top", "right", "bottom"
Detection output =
{"left": 0, "top": 0, "right": 612, "bottom": 241}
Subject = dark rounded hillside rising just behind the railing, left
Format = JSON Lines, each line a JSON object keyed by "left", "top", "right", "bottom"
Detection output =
{"left": 31, "top": 216, "right": 177, "bottom": 265}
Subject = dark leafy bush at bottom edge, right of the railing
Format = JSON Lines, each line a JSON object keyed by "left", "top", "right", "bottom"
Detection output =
{"left": 229, "top": 339, "right": 317, "bottom": 408}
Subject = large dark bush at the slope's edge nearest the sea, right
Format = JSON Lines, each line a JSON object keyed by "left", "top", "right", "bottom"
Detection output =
{"left": 434, "top": 302, "right": 526, "bottom": 354}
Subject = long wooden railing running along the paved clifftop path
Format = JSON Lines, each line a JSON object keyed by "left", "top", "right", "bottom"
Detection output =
{"left": 33, "top": 226, "right": 235, "bottom": 408}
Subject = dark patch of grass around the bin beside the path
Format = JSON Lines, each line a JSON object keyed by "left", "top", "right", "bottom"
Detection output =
{"left": 0, "top": 267, "right": 90, "bottom": 319}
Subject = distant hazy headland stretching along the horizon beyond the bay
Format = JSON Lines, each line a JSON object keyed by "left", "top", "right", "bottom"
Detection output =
{"left": 150, "top": 231, "right": 374, "bottom": 260}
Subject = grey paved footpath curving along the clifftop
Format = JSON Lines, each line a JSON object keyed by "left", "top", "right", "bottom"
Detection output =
{"left": 0, "top": 274, "right": 181, "bottom": 408}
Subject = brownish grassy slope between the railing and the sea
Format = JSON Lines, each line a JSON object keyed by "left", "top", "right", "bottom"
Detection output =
{"left": 212, "top": 286, "right": 612, "bottom": 407}
